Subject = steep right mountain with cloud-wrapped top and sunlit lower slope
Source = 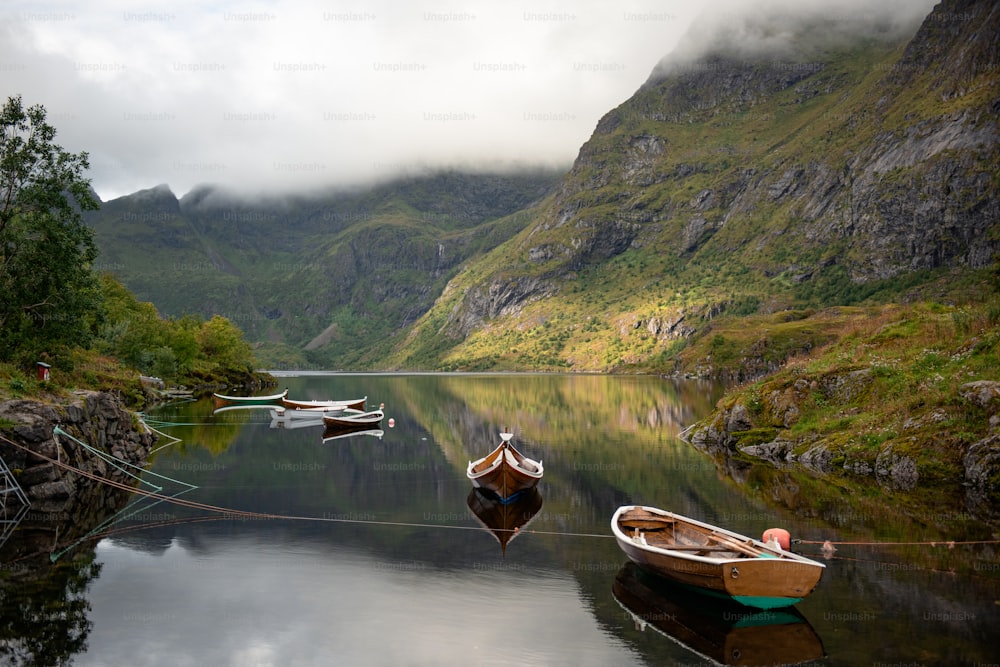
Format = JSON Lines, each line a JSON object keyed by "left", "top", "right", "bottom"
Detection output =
{"left": 395, "top": 0, "right": 1000, "bottom": 370}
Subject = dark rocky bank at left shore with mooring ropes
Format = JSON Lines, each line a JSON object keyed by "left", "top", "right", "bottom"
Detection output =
{"left": 0, "top": 391, "right": 156, "bottom": 512}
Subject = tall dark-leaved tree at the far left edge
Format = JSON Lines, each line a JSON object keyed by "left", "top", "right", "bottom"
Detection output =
{"left": 0, "top": 95, "right": 100, "bottom": 360}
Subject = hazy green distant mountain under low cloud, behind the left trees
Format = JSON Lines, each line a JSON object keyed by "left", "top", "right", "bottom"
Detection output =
{"left": 86, "top": 171, "right": 561, "bottom": 367}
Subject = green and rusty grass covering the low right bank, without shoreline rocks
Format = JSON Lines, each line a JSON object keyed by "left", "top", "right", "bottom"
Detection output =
{"left": 682, "top": 293, "right": 1000, "bottom": 482}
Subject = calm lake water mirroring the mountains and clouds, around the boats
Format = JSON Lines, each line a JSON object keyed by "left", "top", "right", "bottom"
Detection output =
{"left": 0, "top": 374, "right": 1000, "bottom": 666}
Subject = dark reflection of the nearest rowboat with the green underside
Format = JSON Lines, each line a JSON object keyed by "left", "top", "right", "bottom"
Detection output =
{"left": 611, "top": 563, "right": 825, "bottom": 665}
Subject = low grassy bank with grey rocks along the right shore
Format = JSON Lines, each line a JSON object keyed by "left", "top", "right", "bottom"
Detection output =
{"left": 682, "top": 284, "right": 1000, "bottom": 521}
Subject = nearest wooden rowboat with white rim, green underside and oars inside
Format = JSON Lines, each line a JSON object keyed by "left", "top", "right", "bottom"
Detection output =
{"left": 611, "top": 505, "right": 826, "bottom": 609}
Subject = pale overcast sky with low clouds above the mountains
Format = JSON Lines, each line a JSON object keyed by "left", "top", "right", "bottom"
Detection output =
{"left": 0, "top": 0, "right": 932, "bottom": 200}
